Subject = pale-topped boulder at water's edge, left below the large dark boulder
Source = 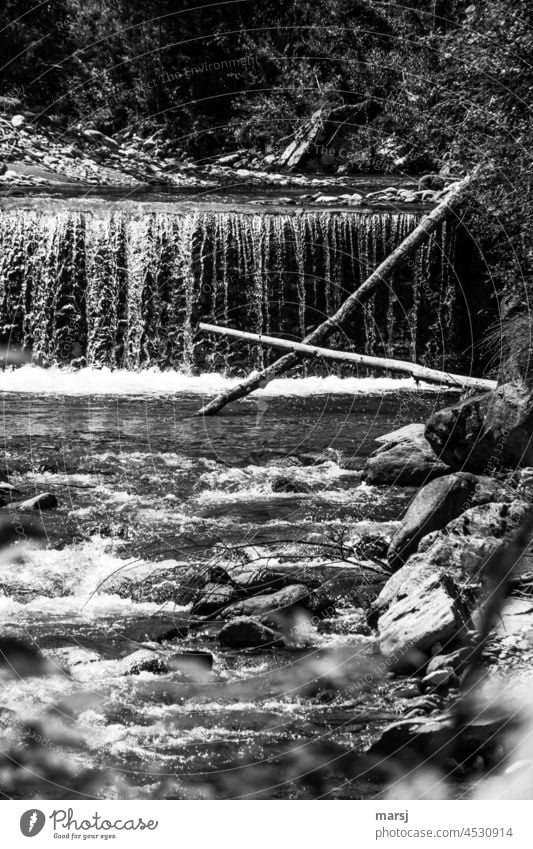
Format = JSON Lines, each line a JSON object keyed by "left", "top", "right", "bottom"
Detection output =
{"left": 363, "top": 424, "right": 449, "bottom": 486}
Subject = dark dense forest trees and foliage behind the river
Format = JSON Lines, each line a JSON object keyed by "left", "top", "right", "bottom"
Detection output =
{"left": 0, "top": 0, "right": 533, "bottom": 378}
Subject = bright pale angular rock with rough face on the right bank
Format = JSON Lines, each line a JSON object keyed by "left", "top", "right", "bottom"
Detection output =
{"left": 378, "top": 575, "right": 466, "bottom": 668}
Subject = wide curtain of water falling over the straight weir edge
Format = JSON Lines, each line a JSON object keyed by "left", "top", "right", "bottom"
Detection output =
{"left": 0, "top": 203, "right": 456, "bottom": 373}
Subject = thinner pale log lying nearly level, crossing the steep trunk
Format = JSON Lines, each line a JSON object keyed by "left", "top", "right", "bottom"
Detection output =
{"left": 198, "top": 322, "right": 496, "bottom": 390}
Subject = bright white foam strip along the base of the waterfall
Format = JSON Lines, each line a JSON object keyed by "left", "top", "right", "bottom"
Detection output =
{"left": 0, "top": 365, "right": 451, "bottom": 397}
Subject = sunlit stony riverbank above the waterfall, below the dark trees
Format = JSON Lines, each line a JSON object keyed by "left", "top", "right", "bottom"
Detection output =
{"left": 0, "top": 98, "right": 453, "bottom": 208}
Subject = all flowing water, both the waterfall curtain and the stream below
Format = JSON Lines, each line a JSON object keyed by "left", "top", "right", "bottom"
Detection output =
{"left": 0, "top": 199, "right": 470, "bottom": 798}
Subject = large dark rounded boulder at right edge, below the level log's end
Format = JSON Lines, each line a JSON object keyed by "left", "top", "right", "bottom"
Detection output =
{"left": 425, "top": 383, "right": 533, "bottom": 474}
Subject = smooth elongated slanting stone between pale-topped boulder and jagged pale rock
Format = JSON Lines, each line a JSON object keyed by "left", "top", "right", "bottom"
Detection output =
{"left": 387, "top": 472, "right": 477, "bottom": 569}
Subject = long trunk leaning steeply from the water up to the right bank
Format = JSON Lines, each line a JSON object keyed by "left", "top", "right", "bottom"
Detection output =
{"left": 198, "top": 171, "right": 478, "bottom": 416}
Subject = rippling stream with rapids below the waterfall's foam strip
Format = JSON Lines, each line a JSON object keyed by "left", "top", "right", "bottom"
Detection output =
{"left": 0, "top": 380, "right": 454, "bottom": 798}
